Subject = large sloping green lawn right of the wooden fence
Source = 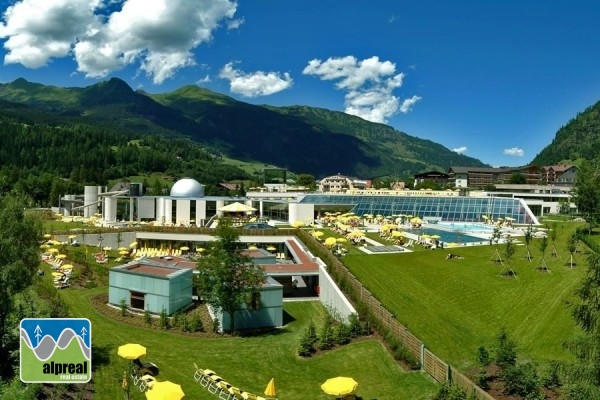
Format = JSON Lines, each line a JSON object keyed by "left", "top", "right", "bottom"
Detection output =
{"left": 344, "top": 223, "right": 586, "bottom": 370}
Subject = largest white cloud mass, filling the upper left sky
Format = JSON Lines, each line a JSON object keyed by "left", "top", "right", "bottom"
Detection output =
{"left": 0, "top": 0, "right": 239, "bottom": 84}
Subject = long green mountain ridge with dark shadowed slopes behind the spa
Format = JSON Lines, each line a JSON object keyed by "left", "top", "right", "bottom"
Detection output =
{"left": 0, "top": 78, "right": 485, "bottom": 178}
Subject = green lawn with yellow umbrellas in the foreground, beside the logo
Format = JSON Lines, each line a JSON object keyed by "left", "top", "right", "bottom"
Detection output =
{"left": 61, "top": 287, "right": 437, "bottom": 400}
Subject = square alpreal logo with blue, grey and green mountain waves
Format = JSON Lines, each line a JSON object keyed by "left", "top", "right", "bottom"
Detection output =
{"left": 21, "top": 318, "right": 92, "bottom": 383}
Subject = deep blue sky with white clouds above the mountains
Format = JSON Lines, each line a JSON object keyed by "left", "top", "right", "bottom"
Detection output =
{"left": 0, "top": 0, "right": 600, "bottom": 166}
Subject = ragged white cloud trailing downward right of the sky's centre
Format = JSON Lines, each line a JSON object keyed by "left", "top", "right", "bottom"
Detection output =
{"left": 302, "top": 56, "right": 421, "bottom": 123}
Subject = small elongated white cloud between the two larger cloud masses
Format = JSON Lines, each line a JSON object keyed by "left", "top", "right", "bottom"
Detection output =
{"left": 219, "top": 63, "right": 294, "bottom": 97}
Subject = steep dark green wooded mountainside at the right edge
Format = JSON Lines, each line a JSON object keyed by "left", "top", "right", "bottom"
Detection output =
{"left": 531, "top": 101, "right": 600, "bottom": 165}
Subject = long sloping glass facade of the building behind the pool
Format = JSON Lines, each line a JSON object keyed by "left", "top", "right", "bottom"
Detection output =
{"left": 300, "top": 194, "right": 538, "bottom": 224}
